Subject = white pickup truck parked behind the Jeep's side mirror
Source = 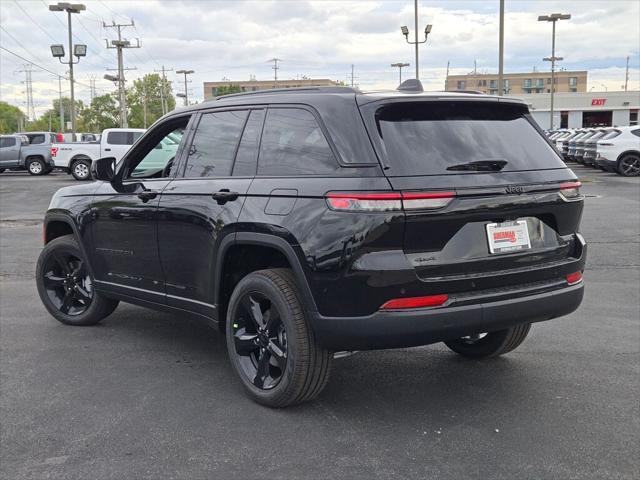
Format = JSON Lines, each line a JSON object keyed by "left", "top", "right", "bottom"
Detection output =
{"left": 51, "top": 128, "right": 145, "bottom": 180}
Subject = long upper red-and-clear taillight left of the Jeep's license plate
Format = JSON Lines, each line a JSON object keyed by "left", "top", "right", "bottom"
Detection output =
{"left": 326, "top": 192, "right": 456, "bottom": 212}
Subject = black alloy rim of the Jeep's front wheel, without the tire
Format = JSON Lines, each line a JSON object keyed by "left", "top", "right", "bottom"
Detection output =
{"left": 43, "top": 251, "right": 93, "bottom": 316}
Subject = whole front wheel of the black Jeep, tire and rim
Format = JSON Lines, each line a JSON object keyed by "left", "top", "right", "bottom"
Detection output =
{"left": 36, "top": 235, "right": 118, "bottom": 326}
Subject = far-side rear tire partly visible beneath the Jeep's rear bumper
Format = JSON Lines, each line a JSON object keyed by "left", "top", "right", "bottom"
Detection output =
{"left": 444, "top": 323, "right": 531, "bottom": 358}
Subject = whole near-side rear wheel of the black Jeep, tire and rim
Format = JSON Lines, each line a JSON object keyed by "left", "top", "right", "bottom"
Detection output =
{"left": 226, "top": 269, "right": 333, "bottom": 408}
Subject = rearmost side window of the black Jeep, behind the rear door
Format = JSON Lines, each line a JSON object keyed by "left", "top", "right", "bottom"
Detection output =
{"left": 258, "top": 108, "right": 338, "bottom": 176}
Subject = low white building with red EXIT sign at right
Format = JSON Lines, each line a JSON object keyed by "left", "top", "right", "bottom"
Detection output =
{"left": 514, "top": 91, "right": 640, "bottom": 129}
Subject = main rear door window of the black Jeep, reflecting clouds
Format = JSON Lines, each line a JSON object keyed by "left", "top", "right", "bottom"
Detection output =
{"left": 184, "top": 110, "right": 248, "bottom": 178}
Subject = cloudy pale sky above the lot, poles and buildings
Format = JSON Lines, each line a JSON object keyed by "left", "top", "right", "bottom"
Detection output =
{"left": 0, "top": 0, "right": 640, "bottom": 118}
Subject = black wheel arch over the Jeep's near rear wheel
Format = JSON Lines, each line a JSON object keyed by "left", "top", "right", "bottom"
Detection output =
{"left": 214, "top": 232, "right": 317, "bottom": 324}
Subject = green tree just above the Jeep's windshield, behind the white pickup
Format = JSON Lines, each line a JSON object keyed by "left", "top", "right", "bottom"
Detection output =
{"left": 127, "top": 73, "right": 176, "bottom": 128}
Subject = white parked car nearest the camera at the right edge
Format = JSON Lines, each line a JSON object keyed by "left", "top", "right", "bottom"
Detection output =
{"left": 596, "top": 125, "right": 640, "bottom": 177}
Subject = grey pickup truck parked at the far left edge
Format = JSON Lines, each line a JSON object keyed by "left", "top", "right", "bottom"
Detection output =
{"left": 0, "top": 132, "right": 55, "bottom": 175}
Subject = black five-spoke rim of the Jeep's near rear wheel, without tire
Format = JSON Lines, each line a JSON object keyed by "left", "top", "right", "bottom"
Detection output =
{"left": 232, "top": 292, "right": 287, "bottom": 390}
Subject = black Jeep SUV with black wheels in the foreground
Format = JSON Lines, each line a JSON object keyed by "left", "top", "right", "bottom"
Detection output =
{"left": 37, "top": 81, "right": 586, "bottom": 407}
